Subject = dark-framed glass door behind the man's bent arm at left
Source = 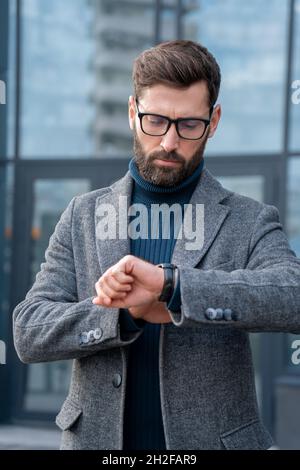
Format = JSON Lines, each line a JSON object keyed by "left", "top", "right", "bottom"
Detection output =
{"left": 12, "top": 160, "right": 128, "bottom": 421}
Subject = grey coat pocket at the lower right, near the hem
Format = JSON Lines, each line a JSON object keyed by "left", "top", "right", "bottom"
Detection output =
{"left": 221, "top": 420, "right": 274, "bottom": 450}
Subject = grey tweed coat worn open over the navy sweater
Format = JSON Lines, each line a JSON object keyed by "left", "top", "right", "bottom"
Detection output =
{"left": 14, "top": 170, "right": 300, "bottom": 450}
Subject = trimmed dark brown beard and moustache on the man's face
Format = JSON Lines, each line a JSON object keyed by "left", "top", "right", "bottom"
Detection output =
{"left": 133, "top": 128, "right": 208, "bottom": 187}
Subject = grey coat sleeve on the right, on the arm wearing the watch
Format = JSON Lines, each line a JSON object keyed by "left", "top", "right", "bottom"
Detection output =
{"left": 170, "top": 204, "right": 300, "bottom": 333}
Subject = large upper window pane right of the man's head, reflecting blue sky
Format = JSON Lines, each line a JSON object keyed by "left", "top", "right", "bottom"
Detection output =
{"left": 183, "top": 0, "right": 289, "bottom": 154}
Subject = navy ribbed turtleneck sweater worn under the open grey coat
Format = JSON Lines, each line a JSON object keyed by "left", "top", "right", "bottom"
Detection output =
{"left": 120, "top": 159, "right": 204, "bottom": 450}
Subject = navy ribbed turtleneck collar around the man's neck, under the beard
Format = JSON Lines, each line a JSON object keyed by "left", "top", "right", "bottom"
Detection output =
{"left": 129, "top": 158, "right": 204, "bottom": 199}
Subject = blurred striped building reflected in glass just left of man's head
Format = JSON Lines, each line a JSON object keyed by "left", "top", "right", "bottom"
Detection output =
{"left": 91, "top": 0, "right": 154, "bottom": 157}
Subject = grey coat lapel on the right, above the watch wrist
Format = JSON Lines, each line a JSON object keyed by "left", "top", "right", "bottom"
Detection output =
{"left": 172, "top": 169, "right": 231, "bottom": 268}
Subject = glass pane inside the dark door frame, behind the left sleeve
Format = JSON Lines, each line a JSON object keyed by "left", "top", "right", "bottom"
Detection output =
{"left": 25, "top": 179, "right": 90, "bottom": 412}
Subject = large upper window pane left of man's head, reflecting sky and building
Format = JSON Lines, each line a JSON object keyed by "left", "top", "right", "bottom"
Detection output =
{"left": 21, "top": 0, "right": 155, "bottom": 158}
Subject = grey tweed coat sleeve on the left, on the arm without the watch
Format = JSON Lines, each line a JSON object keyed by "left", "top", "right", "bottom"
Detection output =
{"left": 13, "top": 198, "right": 142, "bottom": 363}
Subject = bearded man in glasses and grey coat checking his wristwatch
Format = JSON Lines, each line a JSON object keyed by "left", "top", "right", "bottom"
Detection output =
{"left": 14, "top": 41, "right": 300, "bottom": 450}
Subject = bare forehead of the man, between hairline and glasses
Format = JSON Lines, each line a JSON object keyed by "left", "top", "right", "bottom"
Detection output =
{"left": 139, "top": 81, "right": 209, "bottom": 118}
